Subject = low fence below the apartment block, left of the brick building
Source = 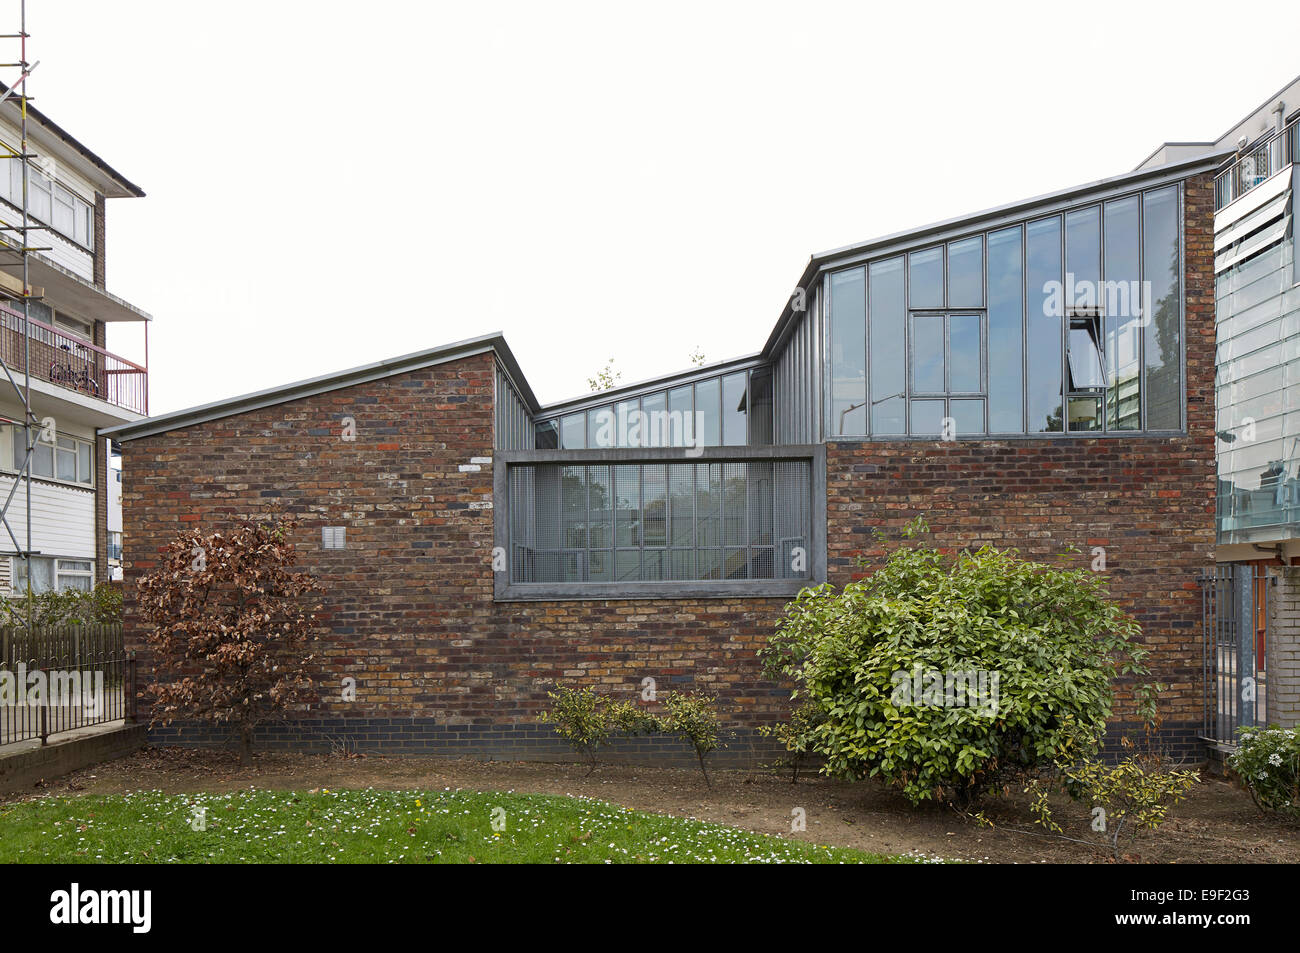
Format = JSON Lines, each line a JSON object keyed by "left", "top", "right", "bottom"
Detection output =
{"left": 0, "top": 624, "right": 135, "bottom": 746}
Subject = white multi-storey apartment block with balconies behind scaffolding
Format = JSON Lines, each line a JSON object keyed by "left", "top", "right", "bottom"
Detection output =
{"left": 0, "top": 86, "right": 150, "bottom": 592}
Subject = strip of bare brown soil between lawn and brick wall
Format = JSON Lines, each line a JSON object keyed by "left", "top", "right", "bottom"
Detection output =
{"left": 0, "top": 748, "right": 1300, "bottom": 863}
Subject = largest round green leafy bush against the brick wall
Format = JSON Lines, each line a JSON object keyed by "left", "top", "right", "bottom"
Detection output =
{"left": 761, "top": 524, "right": 1145, "bottom": 803}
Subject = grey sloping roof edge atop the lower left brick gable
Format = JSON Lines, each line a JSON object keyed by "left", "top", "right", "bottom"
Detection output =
{"left": 100, "top": 332, "right": 541, "bottom": 441}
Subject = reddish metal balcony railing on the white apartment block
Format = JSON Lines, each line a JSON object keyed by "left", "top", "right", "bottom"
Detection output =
{"left": 0, "top": 306, "right": 150, "bottom": 416}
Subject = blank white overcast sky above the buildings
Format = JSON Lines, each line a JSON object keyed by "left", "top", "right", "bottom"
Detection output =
{"left": 17, "top": 0, "right": 1300, "bottom": 412}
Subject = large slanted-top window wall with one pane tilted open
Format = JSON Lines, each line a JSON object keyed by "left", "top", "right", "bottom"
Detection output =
{"left": 826, "top": 185, "right": 1183, "bottom": 439}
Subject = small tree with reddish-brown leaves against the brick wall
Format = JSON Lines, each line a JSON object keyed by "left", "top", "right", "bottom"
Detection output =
{"left": 137, "top": 519, "right": 324, "bottom": 764}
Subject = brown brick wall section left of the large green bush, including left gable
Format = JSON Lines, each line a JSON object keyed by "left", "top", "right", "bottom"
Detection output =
{"left": 124, "top": 355, "right": 787, "bottom": 761}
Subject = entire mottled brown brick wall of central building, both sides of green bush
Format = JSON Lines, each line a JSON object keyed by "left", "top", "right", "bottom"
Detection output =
{"left": 124, "top": 177, "right": 1214, "bottom": 762}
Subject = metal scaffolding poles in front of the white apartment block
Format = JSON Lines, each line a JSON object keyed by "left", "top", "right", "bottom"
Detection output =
{"left": 0, "top": 0, "right": 41, "bottom": 631}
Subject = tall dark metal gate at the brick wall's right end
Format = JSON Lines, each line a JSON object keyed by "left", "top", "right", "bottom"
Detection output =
{"left": 1197, "top": 563, "right": 1277, "bottom": 744}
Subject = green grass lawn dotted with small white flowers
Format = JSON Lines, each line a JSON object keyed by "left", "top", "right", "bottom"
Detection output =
{"left": 0, "top": 788, "right": 914, "bottom": 863}
